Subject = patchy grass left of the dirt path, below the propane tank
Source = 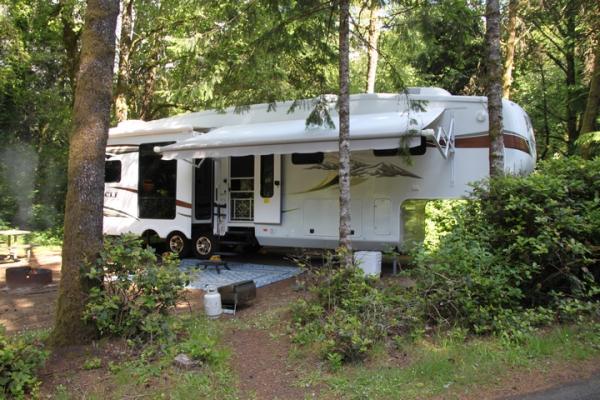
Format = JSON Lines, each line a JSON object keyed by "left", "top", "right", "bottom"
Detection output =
{"left": 54, "top": 316, "right": 238, "bottom": 400}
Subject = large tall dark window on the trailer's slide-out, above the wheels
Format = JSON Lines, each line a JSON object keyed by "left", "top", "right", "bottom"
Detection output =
{"left": 138, "top": 142, "right": 177, "bottom": 219}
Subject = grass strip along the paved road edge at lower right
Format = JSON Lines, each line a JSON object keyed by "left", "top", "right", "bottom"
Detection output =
{"left": 310, "top": 323, "right": 600, "bottom": 399}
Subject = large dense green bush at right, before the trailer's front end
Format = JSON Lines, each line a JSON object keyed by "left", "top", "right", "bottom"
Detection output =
{"left": 411, "top": 157, "right": 600, "bottom": 336}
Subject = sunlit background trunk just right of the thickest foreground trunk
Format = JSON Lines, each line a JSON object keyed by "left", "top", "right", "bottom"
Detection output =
{"left": 115, "top": 0, "right": 133, "bottom": 122}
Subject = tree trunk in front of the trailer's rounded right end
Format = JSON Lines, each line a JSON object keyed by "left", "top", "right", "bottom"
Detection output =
{"left": 485, "top": 0, "right": 504, "bottom": 176}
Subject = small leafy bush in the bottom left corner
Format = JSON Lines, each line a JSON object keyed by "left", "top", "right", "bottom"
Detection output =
{"left": 0, "top": 327, "right": 48, "bottom": 399}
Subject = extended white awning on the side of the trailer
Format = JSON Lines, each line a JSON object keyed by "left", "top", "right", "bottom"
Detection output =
{"left": 155, "top": 108, "right": 444, "bottom": 159}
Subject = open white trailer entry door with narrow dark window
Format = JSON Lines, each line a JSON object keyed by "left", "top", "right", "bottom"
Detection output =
{"left": 254, "top": 154, "right": 281, "bottom": 224}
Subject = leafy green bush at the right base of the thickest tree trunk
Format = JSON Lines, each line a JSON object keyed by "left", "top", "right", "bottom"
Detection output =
{"left": 84, "top": 236, "right": 188, "bottom": 339}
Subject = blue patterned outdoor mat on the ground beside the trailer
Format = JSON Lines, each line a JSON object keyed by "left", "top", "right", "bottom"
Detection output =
{"left": 181, "top": 259, "right": 302, "bottom": 289}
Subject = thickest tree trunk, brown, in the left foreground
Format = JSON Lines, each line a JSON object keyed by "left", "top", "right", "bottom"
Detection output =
{"left": 52, "top": 0, "right": 119, "bottom": 346}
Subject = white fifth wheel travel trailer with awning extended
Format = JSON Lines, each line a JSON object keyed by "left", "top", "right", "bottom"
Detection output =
{"left": 104, "top": 88, "right": 536, "bottom": 257}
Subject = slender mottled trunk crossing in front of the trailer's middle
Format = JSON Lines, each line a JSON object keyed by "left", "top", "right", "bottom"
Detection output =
{"left": 338, "top": 0, "right": 352, "bottom": 267}
